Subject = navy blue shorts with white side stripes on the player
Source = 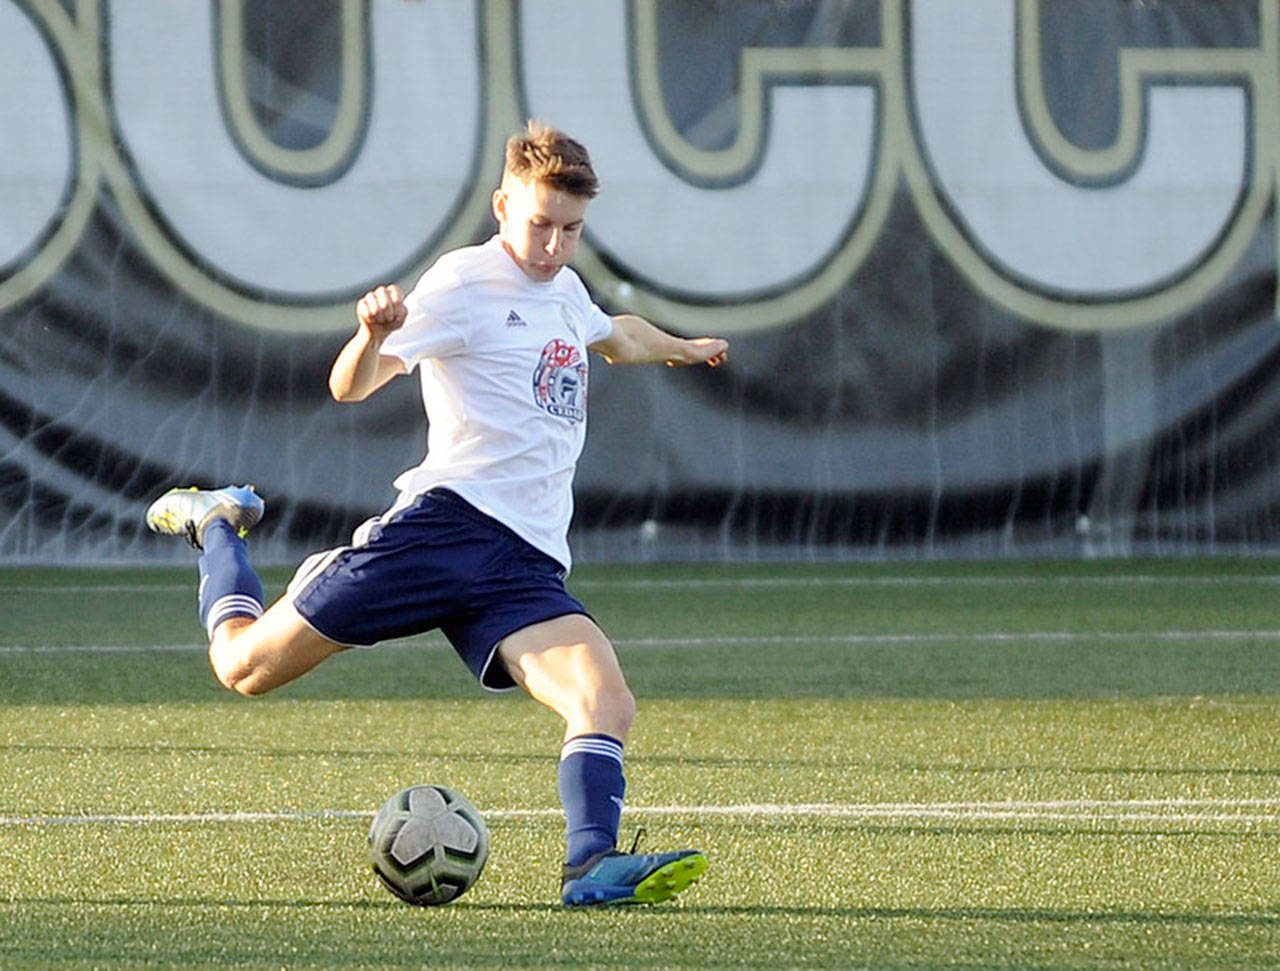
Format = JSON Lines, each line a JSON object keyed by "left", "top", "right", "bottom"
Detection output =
{"left": 289, "top": 489, "right": 586, "bottom": 691}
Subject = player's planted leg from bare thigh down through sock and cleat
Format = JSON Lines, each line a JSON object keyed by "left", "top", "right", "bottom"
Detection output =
{"left": 498, "top": 614, "right": 707, "bottom": 907}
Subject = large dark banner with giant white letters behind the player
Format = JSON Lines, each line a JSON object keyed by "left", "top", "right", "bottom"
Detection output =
{"left": 0, "top": 0, "right": 1280, "bottom": 562}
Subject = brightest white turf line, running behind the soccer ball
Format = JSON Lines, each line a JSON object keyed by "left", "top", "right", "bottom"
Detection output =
{"left": 0, "top": 798, "right": 1280, "bottom": 826}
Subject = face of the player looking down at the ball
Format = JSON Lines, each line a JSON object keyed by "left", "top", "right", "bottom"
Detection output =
{"left": 493, "top": 175, "right": 590, "bottom": 283}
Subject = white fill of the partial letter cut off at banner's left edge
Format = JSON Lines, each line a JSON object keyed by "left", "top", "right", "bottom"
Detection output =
{"left": 0, "top": 0, "right": 76, "bottom": 275}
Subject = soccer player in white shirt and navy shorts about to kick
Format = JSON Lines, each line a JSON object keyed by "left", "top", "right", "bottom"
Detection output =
{"left": 147, "top": 122, "right": 727, "bottom": 906}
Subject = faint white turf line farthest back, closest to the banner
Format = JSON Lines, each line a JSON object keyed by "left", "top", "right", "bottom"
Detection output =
{"left": 0, "top": 573, "right": 1280, "bottom": 596}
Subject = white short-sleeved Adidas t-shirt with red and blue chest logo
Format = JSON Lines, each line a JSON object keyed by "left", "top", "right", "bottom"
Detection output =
{"left": 381, "top": 237, "right": 613, "bottom": 569}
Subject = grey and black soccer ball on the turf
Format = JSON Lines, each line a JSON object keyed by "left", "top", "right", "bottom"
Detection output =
{"left": 369, "top": 785, "right": 489, "bottom": 907}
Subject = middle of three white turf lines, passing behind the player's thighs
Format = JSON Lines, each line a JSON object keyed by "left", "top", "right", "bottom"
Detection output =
{"left": 0, "top": 629, "right": 1280, "bottom": 656}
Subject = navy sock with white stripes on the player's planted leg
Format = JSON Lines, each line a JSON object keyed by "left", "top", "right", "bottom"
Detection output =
{"left": 559, "top": 734, "right": 627, "bottom": 866}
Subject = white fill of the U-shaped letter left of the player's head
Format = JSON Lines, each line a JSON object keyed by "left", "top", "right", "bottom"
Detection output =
{"left": 110, "top": 3, "right": 480, "bottom": 297}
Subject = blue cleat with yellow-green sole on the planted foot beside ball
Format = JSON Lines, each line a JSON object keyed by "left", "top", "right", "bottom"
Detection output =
{"left": 561, "top": 849, "right": 707, "bottom": 907}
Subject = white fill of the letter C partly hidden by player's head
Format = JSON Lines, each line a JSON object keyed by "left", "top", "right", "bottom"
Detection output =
{"left": 520, "top": 0, "right": 876, "bottom": 299}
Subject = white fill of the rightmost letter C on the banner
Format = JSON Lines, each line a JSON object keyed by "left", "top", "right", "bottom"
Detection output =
{"left": 910, "top": 0, "right": 1248, "bottom": 298}
